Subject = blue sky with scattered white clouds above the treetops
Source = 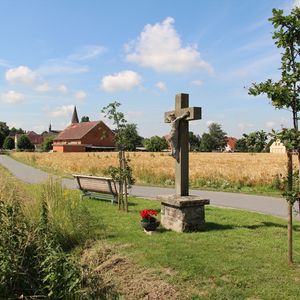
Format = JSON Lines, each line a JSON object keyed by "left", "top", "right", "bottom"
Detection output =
{"left": 0, "top": 0, "right": 300, "bottom": 137}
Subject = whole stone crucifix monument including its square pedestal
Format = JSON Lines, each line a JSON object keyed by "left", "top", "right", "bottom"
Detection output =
{"left": 158, "top": 94, "right": 209, "bottom": 232}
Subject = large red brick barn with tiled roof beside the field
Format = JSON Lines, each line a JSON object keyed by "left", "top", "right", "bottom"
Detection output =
{"left": 53, "top": 121, "right": 115, "bottom": 152}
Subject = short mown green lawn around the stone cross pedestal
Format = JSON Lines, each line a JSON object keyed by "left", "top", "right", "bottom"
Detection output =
{"left": 87, "top": 198, "right": 300, "bottom": 299}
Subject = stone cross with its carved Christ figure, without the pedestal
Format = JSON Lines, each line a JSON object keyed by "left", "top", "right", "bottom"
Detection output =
{"left": 165, "top": 94, "right": 201, "bottom": 196}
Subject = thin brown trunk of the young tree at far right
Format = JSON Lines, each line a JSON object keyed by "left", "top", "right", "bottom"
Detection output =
{"left": 287, "top": 150, "right": 293, "bottom": 264}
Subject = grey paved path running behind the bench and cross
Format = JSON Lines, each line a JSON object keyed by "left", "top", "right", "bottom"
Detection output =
{"left": 0, "top": 155, "right": 287, "bottom": 218}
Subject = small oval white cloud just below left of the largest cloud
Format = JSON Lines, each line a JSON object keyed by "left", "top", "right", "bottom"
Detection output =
{"left": 101, "top": 70, "right": 142, "bottom": 92}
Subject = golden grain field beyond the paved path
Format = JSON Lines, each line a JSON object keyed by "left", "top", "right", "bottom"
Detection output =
{"left": 12, "top": 152, "right": 292, "bottom": 186}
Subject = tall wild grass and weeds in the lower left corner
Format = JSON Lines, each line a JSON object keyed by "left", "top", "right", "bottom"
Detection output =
{"left": 0, "top": 169, "right": 109, "bottom": 299}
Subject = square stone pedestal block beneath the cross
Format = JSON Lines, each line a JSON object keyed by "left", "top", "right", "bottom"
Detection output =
{"left": 157, "top": 195, "right": 209, "bottom": 232}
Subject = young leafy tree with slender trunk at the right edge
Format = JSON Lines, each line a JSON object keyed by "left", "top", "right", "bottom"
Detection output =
{"left": 249, "top": 7, "right": 300, "bottom": 263}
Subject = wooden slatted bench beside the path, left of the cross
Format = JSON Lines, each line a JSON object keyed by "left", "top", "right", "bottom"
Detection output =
{"left": 73, "top": 174, "right": 118, "bottom": 203}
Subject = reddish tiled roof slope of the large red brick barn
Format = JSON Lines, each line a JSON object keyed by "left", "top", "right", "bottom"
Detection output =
{"left": 54, "top": 121, "right": 103, "bottom": 141}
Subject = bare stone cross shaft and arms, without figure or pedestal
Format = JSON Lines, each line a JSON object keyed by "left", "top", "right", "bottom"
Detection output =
{"left": 165, "top": 94, "right": 201, "bottom": 196}
